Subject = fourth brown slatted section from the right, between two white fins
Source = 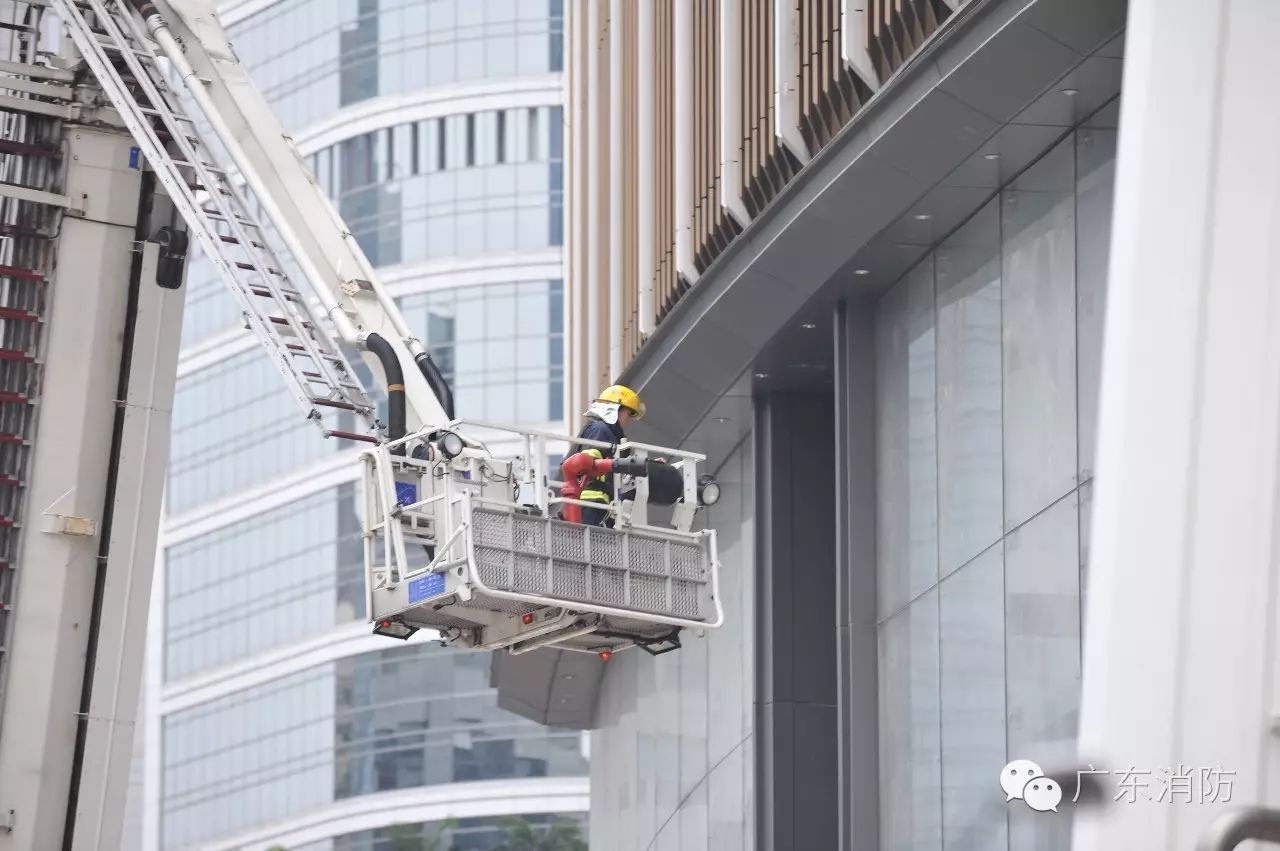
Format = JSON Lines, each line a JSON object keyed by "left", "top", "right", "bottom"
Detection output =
{"left": 692, "top": 0, "right": 739, "bottom": 271}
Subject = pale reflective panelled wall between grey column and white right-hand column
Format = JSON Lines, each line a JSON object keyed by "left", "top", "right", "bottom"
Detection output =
{"left": 877, "top": 120, "right": 1115, "bottom": 851}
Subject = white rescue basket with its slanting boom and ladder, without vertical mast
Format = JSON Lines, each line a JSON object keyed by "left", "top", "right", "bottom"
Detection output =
{"left": 52, "top": 0, "right": 723, "bottom": 658}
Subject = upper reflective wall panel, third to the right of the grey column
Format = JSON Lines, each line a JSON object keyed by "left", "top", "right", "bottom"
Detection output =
{"left": 1001, "top": 138, "right": 1076, "bottom": 530}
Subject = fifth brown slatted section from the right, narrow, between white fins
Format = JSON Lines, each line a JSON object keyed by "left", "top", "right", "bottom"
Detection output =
{"left": 653, "top": 0, "right": 687, "bottom": 317}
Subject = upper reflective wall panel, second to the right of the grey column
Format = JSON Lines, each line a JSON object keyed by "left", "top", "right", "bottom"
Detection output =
{"left": 937, "top": 201, "right": 1004, "bottom": 575}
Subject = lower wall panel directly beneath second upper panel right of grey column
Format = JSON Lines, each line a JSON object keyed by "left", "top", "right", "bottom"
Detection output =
{"left": 940, "top": 544, "right": 1009, "bottom": 851}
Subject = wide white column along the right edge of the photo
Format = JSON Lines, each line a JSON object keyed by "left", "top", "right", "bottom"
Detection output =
{"left": 1075, "top": 0, "right": 1280, "bottom": 851}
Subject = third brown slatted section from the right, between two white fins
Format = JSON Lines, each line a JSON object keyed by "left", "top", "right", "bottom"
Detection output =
{"left": 741, "top": 0, "right": 800, "bottom": 218}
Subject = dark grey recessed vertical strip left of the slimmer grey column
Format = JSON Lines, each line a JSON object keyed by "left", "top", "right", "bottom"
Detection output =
{"left": 755, "top": 394, "right": 838, "bottom": 851}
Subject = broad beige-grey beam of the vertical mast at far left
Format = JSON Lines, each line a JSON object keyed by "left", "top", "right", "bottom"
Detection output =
{"left": 0, "top": 127, "right": 142, "bottom": 851}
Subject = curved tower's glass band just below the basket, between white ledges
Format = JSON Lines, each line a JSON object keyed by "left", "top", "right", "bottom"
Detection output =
{"left": 161, "top": 644, "right": 588, "bottom": 848}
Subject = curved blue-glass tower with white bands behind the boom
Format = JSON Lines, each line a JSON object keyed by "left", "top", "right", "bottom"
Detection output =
{"left": 143, "top": 0, "right": 588, "bottom": 851}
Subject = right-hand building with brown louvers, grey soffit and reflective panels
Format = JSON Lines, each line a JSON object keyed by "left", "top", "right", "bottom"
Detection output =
{"left": 500, "top": 0, "right": 1126, "bottom": 851}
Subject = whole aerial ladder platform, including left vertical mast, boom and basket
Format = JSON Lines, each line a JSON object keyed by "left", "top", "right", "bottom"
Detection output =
{"left": 0, "top": 0, "right": 724, "bottom": 851}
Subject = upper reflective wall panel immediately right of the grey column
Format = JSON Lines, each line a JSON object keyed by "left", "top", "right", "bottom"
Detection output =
{"left": 876, "top": 257, "right": 938, "bottom": 618}
